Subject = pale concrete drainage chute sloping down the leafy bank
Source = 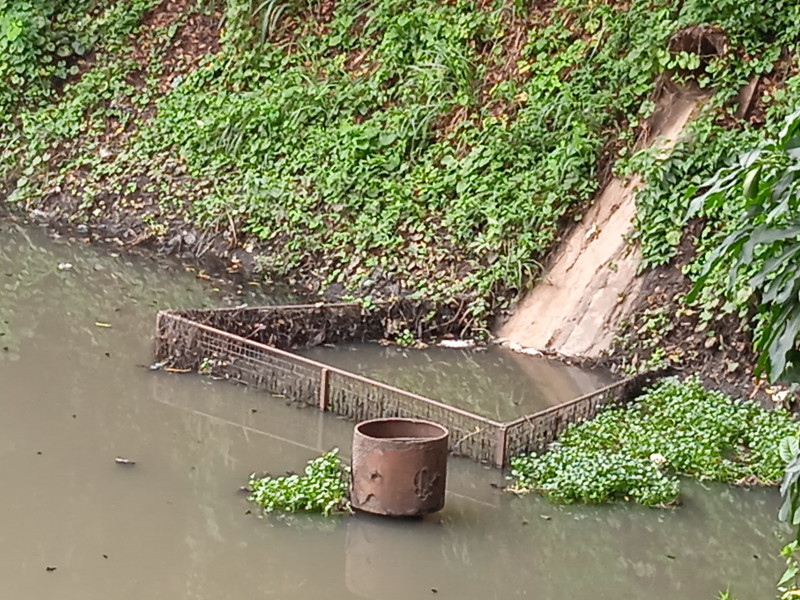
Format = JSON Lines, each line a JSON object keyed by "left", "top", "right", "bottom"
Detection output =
{"left": 498, "top": 92, "right": 699, "bottom": 358}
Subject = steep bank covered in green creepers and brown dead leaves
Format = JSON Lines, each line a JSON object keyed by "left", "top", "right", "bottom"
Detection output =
{"left": 0, "top": 0, "right": 800, "bottom": 363}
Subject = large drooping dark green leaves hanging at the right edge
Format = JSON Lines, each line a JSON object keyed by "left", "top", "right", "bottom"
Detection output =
{"left": 688, "top": 112, "right": 800, "bottom": 381}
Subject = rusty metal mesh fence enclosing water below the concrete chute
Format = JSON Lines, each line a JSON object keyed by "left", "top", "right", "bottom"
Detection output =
{"left": 155, "top": 302, "right": 647, "bottom": 466}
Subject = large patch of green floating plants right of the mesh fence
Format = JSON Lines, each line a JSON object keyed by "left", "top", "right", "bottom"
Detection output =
{"left": 512, "top": 378, "right": 797, "bottom": 506}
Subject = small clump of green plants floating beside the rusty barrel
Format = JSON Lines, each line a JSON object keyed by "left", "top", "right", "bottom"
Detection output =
{"left": 248, "top": 448, "right": 350, "bottom": 515}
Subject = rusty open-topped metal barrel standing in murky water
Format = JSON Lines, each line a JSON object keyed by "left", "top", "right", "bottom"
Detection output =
{"left": 350, "top": 419, "right": 450, "bottom": 517}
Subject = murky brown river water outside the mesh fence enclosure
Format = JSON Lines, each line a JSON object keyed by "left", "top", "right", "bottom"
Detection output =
{"left": 0, "top": 222, "right": 785, "bottom": 600}
